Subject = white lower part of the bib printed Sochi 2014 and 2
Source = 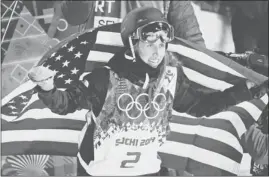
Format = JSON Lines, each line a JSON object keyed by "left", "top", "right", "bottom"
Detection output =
{"left": 89, "top": 130, "right": 161, "bottom": 175}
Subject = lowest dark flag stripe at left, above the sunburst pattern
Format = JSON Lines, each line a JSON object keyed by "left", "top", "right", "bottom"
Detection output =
{"left": 1, "top": 141, "right": 78, "bottom": 157}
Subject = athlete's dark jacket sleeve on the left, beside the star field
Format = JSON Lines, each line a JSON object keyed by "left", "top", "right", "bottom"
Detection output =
{"left": 35, "top": 68, "right": 109, "bottom": 115}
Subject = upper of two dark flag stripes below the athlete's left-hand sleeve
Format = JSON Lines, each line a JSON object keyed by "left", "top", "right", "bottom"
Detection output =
{"left": 2, "top": 117, "right": 85, "bottom": 131}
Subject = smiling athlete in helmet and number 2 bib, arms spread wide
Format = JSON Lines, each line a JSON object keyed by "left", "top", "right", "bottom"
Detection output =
{"left": 29, "top": 7, "right": 266, "bottom": 176}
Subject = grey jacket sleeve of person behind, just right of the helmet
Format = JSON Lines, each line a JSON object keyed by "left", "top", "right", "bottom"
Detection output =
{"left": 167, "top": 0, "right": 205, "bottom": 47}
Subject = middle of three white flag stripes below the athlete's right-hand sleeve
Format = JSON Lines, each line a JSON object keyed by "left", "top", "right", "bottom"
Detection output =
{"left": 169, "top": 123, "right": 243, "bottom": 153}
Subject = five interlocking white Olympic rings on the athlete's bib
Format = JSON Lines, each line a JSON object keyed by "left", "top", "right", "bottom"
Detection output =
{"left": 117, "top": 93, "right": 167, "bottom": 120}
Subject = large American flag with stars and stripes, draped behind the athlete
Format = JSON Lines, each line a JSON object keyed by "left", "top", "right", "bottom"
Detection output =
{"left": 2, "top": 24, "right": 268, "bottom": 175}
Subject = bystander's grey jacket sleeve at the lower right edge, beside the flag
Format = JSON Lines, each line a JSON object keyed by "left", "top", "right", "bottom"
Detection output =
{"left": 241, "top": 124, "right": 268, "bottom": 164}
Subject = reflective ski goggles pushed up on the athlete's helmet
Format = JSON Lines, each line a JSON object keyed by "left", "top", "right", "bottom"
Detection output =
{"left": 133, "top": 22, "right": 174, "bottom": 43}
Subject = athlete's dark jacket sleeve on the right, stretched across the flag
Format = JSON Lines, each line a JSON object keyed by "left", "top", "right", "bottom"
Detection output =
{"left": 173, "top": 67, "right": 252, "bottom": 117}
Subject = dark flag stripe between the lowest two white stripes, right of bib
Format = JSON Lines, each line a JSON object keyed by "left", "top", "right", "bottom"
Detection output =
{"left": 167, "top": 131, "right": 242, "bottom": 163}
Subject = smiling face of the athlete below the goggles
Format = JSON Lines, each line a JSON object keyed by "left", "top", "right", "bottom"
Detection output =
{"left": 137, "top": 39, "right": 166, "bottom": 68}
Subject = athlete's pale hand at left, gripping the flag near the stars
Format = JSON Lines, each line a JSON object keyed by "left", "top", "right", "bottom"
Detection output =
{"left": 28, "top": 66, "right": 55, "bottom": 91}
